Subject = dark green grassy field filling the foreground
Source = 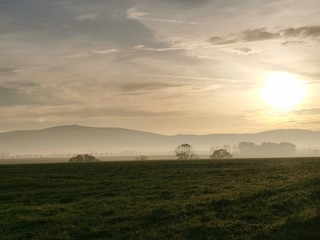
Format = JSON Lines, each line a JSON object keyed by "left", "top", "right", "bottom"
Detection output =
{"left": 0, "top": 158, "right": 320, "bottom": 240}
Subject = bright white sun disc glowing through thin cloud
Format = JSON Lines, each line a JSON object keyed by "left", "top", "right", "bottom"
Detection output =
{"left": 260, "top": 72, "right": 306, "bottom": 110}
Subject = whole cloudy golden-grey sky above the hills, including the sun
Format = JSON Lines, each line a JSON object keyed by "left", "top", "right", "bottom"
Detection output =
{"left": 0, "top": 0, "right": 320, "bottom": 135}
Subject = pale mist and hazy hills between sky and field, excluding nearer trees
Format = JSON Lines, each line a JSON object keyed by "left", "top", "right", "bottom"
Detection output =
{"left": 0, "top": 125, "right": 320, "bottom": 160}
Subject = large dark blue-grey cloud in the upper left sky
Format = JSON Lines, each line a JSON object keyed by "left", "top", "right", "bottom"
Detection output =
{"left": 0, "top": 1, "right": 157, "bottom": 49}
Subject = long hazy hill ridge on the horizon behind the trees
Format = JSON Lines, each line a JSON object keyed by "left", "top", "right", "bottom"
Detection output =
{"left": 0, "top": 125, "right": 320, "bottom": 154}
